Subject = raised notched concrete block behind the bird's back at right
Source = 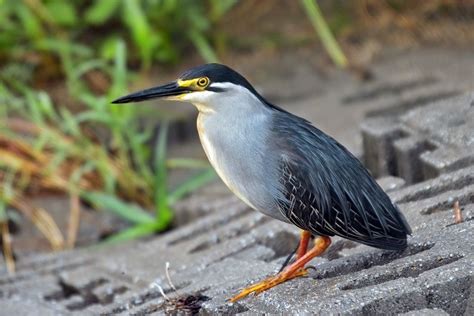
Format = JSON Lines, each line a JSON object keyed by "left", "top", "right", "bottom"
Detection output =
{"left": 362, "top": 93, "right": 474, "bottom": 183}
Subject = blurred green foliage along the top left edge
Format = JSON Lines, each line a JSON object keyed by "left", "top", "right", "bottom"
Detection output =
{"left": 0, "top": 0, "right": 237, "bottom": 74}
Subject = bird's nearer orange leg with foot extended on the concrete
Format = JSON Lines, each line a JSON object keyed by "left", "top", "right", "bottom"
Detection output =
{"left": 230, "top": 233, "right": 331, "bottom": 302}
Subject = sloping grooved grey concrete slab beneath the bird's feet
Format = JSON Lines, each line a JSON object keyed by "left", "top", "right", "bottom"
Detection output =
{"left": 2, "top": 142, "right": 474, "bottom": 315}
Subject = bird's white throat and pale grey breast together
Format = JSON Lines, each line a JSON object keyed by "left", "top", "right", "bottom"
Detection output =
{"left": 189, "top": 83, "right": 286, "bottom": 219}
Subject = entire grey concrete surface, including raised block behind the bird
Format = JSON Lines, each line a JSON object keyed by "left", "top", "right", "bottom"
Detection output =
{"left": 0, "top": 48, "right": 474, "bottom": 315}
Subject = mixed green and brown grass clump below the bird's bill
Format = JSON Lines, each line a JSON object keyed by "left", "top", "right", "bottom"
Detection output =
{"left": 0, "top": 40, "right": 215, "bottom": 272}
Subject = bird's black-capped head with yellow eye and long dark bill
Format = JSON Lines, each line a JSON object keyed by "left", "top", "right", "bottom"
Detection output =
{"left": 112, "top": 63, "right": 263, "bottom": 111}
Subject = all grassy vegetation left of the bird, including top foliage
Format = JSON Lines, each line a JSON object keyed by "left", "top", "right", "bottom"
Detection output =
{"left": 0, "top": 0, "right": 237, "bottom": 254}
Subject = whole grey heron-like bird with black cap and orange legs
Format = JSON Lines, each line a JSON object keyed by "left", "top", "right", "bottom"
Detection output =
{"left": 112, "top": 63, "right": 411, "bottom": 302}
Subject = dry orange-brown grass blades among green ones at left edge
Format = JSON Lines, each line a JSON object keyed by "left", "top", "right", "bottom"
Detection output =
{"left": 0, "top": 119, "right": 148, "bottom": 272}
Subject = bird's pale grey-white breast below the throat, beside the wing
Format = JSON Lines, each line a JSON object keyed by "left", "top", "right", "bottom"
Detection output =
{"left": 197, "top": 112, "right": 286, "bottom": 221}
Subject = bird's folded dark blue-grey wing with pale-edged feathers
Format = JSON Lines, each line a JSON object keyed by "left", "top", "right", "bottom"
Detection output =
{"left": 275, "top": 111, "right": 410, "bottom": 250}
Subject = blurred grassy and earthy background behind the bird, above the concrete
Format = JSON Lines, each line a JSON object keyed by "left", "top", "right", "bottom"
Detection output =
{"left": 0, "top": 0, "right": 474, "bottom": 271}
